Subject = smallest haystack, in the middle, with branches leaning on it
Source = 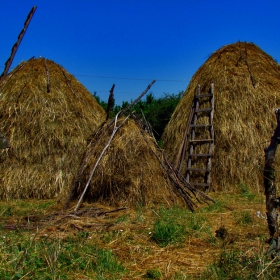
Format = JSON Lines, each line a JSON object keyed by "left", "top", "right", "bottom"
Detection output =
{"left": 69, "top": 118, "right": 210, "bottom": 209}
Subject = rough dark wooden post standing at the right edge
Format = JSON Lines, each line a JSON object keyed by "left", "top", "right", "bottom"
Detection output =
{"left": 264, "top": 109, "right": 280, "bottom": 255}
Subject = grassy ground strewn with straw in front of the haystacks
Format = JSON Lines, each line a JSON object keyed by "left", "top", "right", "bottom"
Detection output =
{"left": 0, "top": 189, "right": 272, "bottom": 280}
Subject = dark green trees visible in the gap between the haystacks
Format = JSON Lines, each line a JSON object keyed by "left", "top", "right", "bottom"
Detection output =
{"left": 93, "top": 91, "right": 184, "bottom": 141}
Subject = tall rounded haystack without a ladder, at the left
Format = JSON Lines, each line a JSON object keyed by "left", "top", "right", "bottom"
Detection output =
{"left": 0, "top": 58, "right": 105, "bottom": 199}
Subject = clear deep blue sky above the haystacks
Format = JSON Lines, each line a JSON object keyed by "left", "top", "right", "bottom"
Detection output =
{"left": 0, "top": 0, "right": 280, "bottom": 104}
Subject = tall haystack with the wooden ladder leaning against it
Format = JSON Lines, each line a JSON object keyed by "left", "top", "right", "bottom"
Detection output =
{"left": 163, "top": 42, "right": 280, "bottom": 190}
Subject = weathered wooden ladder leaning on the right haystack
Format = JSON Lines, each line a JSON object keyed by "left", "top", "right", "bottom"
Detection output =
{"left": 177, "top": 84, "right": 214, "bottom": 191}
